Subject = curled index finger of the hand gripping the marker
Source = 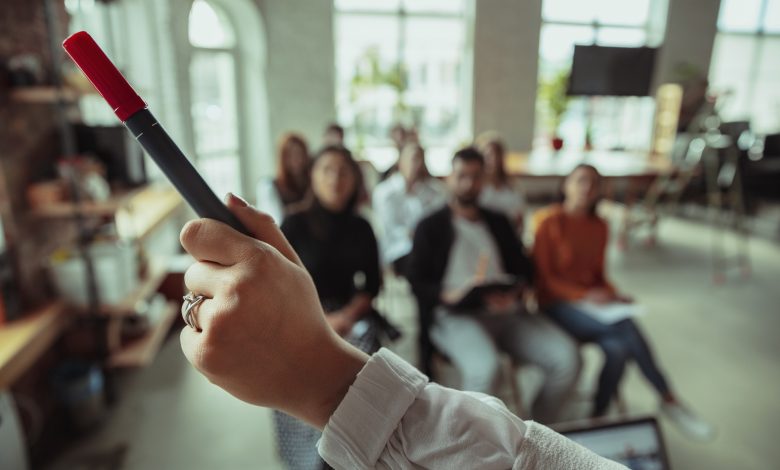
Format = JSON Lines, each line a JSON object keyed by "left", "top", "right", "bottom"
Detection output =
{"left": 179, "top": 219, "right": 259, "bottom": 266}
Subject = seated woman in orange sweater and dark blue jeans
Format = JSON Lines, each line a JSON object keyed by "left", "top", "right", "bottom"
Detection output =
{"left": 533, "top": 165, "right": 712, "bottom": 438}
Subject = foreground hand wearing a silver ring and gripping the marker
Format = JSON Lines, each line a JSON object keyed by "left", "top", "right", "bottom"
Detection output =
{"left": 180, "top": 195, "right": 368, "bottom": 429}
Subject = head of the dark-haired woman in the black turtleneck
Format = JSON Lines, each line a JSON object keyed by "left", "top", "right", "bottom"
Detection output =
{"left": 311, "top": 145, "right": 360, "bottom": 212}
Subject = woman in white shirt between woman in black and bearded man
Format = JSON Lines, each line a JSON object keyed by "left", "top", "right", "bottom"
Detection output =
{"left": 373, "top": 144, "right": 447, "bottom": 275}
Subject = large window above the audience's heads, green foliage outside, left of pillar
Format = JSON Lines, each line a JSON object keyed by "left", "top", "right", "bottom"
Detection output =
{"left": 335, "top": 0, "right": 469, "bottom": 173}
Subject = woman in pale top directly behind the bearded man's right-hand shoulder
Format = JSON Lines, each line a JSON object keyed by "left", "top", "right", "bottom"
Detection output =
{"left": 477, "top": 135, "right": 525, "bottom": 233}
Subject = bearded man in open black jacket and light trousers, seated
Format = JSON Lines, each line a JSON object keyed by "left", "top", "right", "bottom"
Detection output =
{"left": 407, "top": 148, "right": 580, "bottom": 423}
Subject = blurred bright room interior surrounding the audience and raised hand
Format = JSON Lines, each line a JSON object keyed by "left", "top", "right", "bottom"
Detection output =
{"left": 0, "top": 0, "right": 780, "bottom": 469}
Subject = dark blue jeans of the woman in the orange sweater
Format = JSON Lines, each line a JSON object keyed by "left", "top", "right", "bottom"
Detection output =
{"left": 545, "top": 302, "right": 669, "bottom": 416}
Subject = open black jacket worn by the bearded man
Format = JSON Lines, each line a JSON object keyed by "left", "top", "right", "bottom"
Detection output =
{"left": 406, "top": 206, "right": 533, "bottom": 375}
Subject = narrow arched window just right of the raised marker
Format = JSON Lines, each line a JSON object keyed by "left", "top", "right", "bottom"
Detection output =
{"left": 188, "top": 0, "right": 241, "bottom": 196}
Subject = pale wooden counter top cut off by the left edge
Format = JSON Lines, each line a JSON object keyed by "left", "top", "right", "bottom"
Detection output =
{"left": 0, "top": 302, "right": 73, "bottom": 390}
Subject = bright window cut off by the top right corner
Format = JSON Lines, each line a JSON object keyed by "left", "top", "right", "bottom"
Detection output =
{"left": 709, "top": 0, "right": 780, "bottom": 133}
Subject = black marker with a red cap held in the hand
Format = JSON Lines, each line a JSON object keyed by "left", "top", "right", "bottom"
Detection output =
{"left": 62, "top": 31, "right": 252, "bottom": 236}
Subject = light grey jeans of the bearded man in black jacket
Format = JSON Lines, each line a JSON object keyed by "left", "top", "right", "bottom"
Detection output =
{"left": 430, "top": 308, "right": 581, "bottom": 423}
